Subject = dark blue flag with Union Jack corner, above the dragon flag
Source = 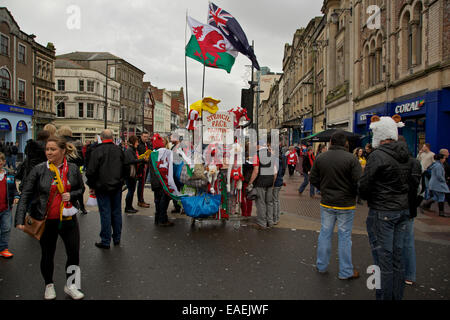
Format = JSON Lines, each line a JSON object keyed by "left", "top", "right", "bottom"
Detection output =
{"left": 208, "top": 2, "right": 259, "bottom": 70}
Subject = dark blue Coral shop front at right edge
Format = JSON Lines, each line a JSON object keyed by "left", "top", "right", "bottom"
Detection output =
{"left": 389, "top": 89, "right": 450, "bottom": 156}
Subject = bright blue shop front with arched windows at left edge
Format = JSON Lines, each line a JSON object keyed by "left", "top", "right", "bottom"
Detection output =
{"left": 0, "top": 104, "right": 33, "bottom": 153}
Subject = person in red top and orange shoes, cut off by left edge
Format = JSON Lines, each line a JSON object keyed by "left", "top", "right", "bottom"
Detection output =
{"left": 0, "top": 152, "right": 20, "bottom": 259}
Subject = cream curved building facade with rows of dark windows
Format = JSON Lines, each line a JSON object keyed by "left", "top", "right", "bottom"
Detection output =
{"left": 54, "top": 58, "right": 121, "bottom": 143}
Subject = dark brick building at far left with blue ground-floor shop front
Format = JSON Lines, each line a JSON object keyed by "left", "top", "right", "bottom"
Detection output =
{"left": 0, "top": 7, "right": 55, "bottom": 153}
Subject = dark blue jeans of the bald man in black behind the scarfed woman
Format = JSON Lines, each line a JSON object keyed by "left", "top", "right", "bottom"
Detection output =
{"left": 96, "top": 189, "right": 122, "bottom": 246}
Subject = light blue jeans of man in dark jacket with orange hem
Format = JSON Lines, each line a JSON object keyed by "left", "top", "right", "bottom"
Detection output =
{"left": 316, "top": 206, "right": 355, "bottom": 278}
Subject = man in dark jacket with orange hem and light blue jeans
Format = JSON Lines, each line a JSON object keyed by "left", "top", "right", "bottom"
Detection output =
{"left": 311, "top": 132, "right": 362, "bottom": 280}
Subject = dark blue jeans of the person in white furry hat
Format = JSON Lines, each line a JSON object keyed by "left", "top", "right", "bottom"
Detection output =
{"left": 366, "top": 209, "right": 409, "bottom": 300}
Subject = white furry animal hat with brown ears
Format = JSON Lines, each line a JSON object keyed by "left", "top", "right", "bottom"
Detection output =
{"left": 370, "top": 115, "right": 405, "bottom": 148}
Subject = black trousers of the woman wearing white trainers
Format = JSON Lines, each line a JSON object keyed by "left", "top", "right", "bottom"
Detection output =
{"left": 40, "top": 216, "right": 80, "bottom": 285}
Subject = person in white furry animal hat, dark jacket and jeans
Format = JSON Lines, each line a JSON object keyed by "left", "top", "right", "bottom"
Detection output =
{"left": 359, "top": 116, "right": 412, "bottom": 300}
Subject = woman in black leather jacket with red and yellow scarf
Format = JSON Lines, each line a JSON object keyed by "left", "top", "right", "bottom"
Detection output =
{"left": 15, "top": 136, "right": 84, "bottom": 300}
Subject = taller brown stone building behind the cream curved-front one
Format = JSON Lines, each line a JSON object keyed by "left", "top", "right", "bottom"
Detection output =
{"left": 58, "top": 51, "right": 145, "bottom": 139}
